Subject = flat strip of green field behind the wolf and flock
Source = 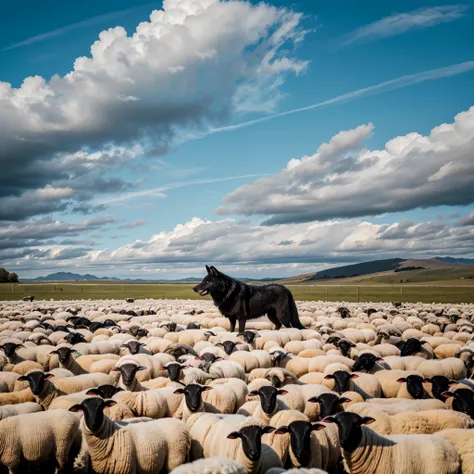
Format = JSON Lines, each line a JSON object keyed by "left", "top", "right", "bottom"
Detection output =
{"left": 0, "top": 283, "right": 474, "bottom": 303}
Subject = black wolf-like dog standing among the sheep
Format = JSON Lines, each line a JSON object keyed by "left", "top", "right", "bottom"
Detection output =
{"left": 194, "top": 265, "right": 306, "bottom": 333}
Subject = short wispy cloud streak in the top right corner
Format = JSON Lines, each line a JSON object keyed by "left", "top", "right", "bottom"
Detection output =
{"left": 343, "top": 5, "right": 470, "bottom": 46}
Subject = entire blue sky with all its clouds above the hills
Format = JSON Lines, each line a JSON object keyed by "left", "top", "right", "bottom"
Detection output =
{"left": 0, "top": 0, "right": 474, "bottom": 278}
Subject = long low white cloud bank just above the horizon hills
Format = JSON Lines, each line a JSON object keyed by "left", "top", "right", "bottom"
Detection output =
{"left": 4, "top": 218, "right": 474, "bottom": 275}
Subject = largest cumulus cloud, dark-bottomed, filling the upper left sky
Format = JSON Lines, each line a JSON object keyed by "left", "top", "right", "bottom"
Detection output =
{"left": 0, "top": 0, "right": 307, "bottom": 219}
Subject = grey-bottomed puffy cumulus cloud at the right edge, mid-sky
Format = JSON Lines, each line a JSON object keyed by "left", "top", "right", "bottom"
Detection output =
{"left": 217, "top": 107, "right": 474, "bottom": 225}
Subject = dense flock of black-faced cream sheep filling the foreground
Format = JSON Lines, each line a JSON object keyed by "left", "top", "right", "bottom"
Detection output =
{"left": 0, "top": 298, "right": 474, "bottom": 474}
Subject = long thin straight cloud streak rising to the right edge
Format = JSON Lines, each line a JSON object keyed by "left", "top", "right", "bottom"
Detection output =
{"left": 206, "top": 61, "right": 474, "bottom": 133}
